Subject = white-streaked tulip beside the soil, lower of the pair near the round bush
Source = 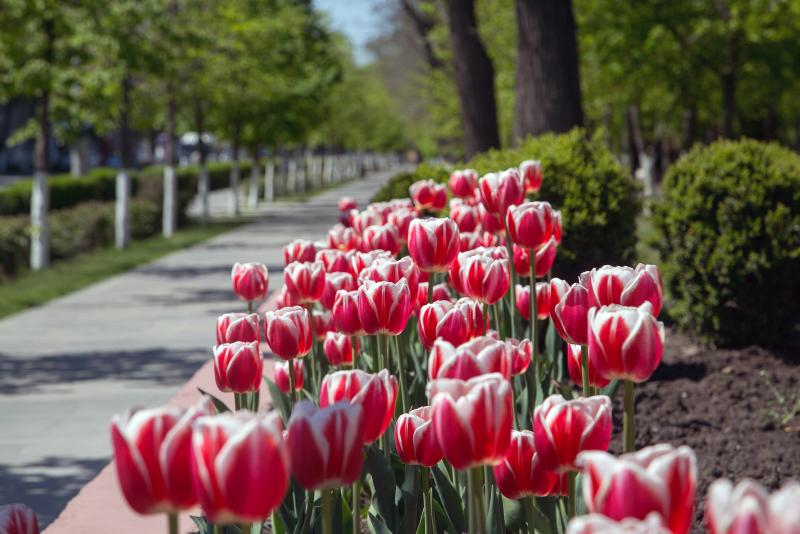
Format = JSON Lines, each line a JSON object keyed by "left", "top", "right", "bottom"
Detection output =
{"left": 589, "top": 303, "right": 664, "bottom": 382}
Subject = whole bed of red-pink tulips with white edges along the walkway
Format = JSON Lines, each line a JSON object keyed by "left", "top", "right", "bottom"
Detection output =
{"left": 95, "top": 162, "right": 800, "bottom": 534}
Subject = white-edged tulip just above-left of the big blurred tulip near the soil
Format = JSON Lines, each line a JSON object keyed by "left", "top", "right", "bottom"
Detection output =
{"left": 533, "top": 395, "right": 611, "bottom": 472}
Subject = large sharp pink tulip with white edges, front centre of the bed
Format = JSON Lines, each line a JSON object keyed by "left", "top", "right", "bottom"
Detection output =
{"left": 428, "top": 373, "right": 514, "bottom": 470}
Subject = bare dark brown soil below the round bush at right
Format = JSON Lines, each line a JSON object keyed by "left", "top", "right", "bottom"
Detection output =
{"left": 612, "top": 331, "right": 800, "bottom": 533}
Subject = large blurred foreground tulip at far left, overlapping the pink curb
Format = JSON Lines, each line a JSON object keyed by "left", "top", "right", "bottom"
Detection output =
{"left": 111, "top": 396, "right": 215, "bottom": 516}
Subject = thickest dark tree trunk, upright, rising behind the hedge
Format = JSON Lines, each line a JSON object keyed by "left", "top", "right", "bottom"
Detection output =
{"left": 514, "top": 0, "right": 583, "bottom": 141}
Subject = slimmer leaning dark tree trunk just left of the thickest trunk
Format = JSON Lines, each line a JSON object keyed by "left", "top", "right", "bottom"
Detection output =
{"left": 440, "top": 0, "right": 500, "bottom": 159}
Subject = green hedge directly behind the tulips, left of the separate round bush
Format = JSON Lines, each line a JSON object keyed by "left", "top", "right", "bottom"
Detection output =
{"left": 374, "top": 129, "right": 641, "bottom": 280}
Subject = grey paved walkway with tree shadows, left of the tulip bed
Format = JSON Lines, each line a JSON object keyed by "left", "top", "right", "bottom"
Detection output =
{"left": 0, "top": 172, "right": 400, "bottom": 526}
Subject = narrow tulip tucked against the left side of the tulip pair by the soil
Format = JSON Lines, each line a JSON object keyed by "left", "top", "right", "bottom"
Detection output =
{"left": 550, "top": 278, "right": 591, "bottom": 345}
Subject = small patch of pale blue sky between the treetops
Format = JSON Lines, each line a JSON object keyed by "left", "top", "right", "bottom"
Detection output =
{"left": 314, "top": 0, "right": 383, "bottom": 64}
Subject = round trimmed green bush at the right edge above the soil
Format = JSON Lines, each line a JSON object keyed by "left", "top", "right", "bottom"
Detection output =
{"left": 653, "top": 140, "right": 800, "bottom": 345}
